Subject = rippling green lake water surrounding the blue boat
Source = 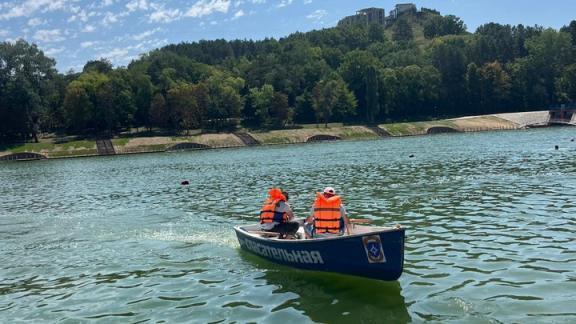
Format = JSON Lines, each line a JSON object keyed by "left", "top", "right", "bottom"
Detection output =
{"left": 0, "top": 128, "right": 576, "bottom": 323}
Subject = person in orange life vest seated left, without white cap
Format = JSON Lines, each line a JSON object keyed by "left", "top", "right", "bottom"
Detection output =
{"left": 260, "top": 188, "right": 300, "bottom": 238}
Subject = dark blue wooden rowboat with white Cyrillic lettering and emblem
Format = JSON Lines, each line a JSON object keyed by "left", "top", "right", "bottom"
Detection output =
{"left": 234, "top": 220, "right": 406, "bottom": 281}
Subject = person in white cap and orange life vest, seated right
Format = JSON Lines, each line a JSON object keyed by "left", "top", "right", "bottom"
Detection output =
{"left": 304, "top": 187, "right": 350, "bottom": 237}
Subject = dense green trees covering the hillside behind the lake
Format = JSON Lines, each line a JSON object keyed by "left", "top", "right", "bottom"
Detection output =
{"left": 0, "top": 9, "right": 576, "bottom": 141}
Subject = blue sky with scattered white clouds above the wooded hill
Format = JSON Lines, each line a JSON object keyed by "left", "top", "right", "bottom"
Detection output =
{"left": 0, "top": 0, "right": 576, "bottom": 73}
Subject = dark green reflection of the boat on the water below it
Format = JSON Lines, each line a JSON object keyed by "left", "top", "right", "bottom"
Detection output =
{"left": 241, "top": 251, "right": 410, "bottom": 323}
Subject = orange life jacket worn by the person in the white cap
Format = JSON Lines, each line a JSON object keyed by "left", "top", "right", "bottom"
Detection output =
{"left": 314, "top": 192, "right": 342, "bottom": 234}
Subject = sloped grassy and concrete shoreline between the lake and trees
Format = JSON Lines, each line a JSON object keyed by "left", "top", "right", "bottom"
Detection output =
{"left": 0, "top": 110, "right": 576, "bottom": 161}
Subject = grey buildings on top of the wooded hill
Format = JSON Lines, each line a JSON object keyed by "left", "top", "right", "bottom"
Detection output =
{"left": 338, "top": 3, "right": 417, "bottom": 26}
